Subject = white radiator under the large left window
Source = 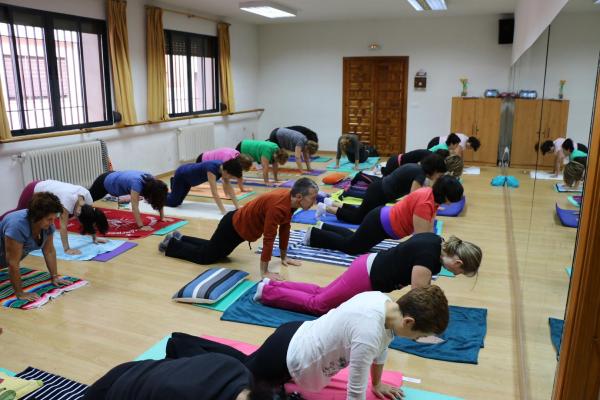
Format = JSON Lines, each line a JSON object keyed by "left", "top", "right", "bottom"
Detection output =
{"left": 20, "top": 140, "right": 108, "bottom": 187}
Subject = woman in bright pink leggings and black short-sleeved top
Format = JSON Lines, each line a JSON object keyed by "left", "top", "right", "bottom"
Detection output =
{"left": 255, "top": 232, "right": 482, "bottom": 315}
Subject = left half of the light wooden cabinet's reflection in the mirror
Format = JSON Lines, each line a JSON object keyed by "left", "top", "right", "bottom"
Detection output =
{"left": 510, "top": 99, "right": 542, "bottom": 167}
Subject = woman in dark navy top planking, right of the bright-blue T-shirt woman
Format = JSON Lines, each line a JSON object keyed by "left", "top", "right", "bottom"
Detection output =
{"left": 166, "top": 159, "right": 242, "bottom": 214}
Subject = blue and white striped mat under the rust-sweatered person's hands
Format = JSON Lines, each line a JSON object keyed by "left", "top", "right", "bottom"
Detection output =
{"left": 256, "top": 230, "right": 398, "bottom": 267}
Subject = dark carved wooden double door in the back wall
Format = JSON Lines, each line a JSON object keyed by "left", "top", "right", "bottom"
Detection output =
{"left": 342, "top": 57, "right": 408, "bottom": 155}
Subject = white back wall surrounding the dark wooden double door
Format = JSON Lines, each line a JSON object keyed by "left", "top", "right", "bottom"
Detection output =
{"left": 259, "top": 16, "right": 511, "bottom": 150}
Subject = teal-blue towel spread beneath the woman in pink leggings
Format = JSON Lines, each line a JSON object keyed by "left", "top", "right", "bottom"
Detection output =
{"left": 221, "top": 287, "right": 487, "bottom": 364}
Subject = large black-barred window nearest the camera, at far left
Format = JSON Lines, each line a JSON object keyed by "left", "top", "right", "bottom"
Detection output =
{"left": 0, "top": 5, "right": 112, "bottom": 135}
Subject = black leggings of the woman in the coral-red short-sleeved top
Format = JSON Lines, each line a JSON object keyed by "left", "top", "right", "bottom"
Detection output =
{"left": 310, "top": 207, "right": 390, "bottom": 254}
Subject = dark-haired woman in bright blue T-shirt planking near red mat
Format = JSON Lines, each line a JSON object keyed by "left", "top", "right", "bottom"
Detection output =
{"left": 90, "top": 170, "right": 169, "bottom": 231}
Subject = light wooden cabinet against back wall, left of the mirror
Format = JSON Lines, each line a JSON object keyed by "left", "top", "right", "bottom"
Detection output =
{"left": 450, "top": 97, "right": 502, "bottom": 165}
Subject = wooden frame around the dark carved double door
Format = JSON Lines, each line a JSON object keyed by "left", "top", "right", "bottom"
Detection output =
{"left": 340, "top": 56, "right": 410, "bottom": 153}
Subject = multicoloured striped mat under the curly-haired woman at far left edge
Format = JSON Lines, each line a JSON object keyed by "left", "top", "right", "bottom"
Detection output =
{"left": 0, "top": 268, "right": 88, "bottom": 310}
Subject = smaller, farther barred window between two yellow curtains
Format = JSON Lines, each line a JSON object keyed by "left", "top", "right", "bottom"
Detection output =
{"left": 165, "top": 30, "right": 219, "bottom": 117}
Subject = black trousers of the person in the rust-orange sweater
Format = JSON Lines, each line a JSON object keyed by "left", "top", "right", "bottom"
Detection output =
{"left": 165, "top": 211, "right": 244, "bottom": 264}
